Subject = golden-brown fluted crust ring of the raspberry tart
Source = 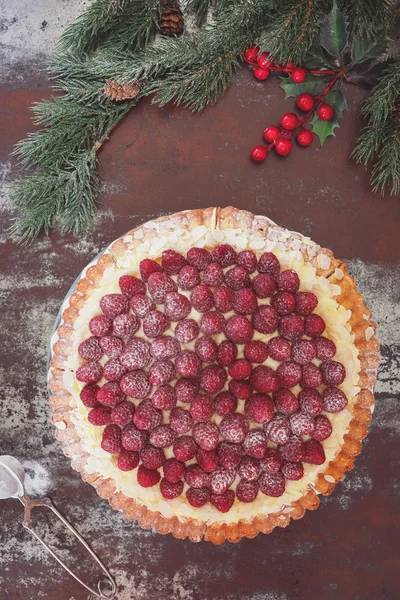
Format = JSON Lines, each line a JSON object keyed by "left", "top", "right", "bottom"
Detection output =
{"left": 49, "top": 207, "right": 379, "bottom": 544}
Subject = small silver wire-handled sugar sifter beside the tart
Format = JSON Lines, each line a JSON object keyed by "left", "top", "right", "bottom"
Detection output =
{"left": 0, "top": 456, "right": 117, "bottom": 600}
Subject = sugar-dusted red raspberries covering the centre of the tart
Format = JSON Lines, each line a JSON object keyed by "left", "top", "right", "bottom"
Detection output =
{"left": 76, "top": 244, "right": 347, "bottom": 512}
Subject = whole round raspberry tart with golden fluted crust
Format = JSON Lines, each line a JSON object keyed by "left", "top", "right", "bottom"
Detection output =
{"left": 49, "top": 207, "right": 379, "bottom": 544}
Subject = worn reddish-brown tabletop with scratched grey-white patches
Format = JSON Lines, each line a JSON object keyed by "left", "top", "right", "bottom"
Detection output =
{"left": 0, "top": 0, "right": 400, "bottom": 600}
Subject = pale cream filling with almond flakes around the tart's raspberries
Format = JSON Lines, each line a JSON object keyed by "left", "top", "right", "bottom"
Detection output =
{"left": 53, "top": 222, "right": 360, "bottom": 524}
